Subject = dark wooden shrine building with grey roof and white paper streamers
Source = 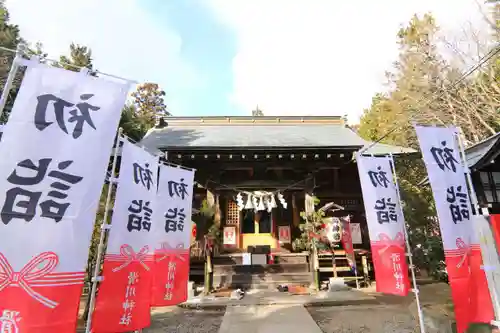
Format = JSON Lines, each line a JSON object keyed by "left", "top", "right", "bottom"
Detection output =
{"left": 140, "top": 116, "right": 415, "bottom": 290}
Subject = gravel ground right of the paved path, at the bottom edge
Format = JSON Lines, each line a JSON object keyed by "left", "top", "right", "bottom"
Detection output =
{"left": 308, "top": 305, "right": 419, "bottom": 333}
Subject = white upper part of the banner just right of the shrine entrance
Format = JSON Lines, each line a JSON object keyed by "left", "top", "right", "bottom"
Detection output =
{"left": 356, "top": 155, "right": 405, "bottom": 242}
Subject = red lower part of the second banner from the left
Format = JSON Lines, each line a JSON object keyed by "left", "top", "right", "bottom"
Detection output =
{"left": 92, "top": 245, "right": 153, "bottom": 333}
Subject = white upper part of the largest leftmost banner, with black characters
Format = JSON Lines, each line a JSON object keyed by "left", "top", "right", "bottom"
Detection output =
{"left": 0, "top": 64, "right": 129, "bottom": 272}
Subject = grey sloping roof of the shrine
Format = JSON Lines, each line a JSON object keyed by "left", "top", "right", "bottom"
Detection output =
{"left": 141, "top": 116, "right": 415, "bottom": 155}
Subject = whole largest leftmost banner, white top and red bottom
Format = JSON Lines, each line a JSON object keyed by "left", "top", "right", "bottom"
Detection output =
{"left": 0, "top": 64, "right": 129, "bottom": 333}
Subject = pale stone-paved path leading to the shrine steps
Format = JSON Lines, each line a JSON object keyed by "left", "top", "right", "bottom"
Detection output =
{"left": 219, "top": 304, "right": 322, "bottom": 333}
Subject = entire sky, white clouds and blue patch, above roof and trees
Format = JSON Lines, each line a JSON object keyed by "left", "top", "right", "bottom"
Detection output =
{"left": 6, "top": 0, "right": 494, "bottom": 123}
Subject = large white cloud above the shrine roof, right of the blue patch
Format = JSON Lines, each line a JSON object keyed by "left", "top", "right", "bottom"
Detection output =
{"left": 208, "top": 0, "right": 490, "bottom": 121}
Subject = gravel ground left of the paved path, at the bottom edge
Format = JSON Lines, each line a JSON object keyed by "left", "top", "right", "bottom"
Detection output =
{"left": 143, "top": 307, "right": 224, "bottom": 333}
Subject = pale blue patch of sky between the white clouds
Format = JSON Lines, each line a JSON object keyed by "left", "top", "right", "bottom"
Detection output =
{"left": 143, "top": 0, "right": 239, "bottom": 116}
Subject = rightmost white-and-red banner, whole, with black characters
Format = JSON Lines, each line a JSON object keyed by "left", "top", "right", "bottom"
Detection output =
{"left": 415, "top": 126, "right": 493, "bottom": 333}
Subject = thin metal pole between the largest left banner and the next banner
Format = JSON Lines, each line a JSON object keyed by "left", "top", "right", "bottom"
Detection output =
{"left": 85, "top": 128, "right": 123, "bottom": 333}
